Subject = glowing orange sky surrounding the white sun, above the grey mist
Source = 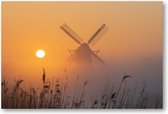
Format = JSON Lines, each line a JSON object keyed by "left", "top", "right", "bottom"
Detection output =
{"left": 2, "top": 2, "right": 163, "bottom": 88}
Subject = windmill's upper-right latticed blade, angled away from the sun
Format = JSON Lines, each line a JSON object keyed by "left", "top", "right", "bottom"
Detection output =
{"left": 88, "top": 24, "right": 108, "bottom": 46}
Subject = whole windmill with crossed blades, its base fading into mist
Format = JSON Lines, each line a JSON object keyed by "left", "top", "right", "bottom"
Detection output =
{"left": 60, "top": 24, "right": 108, "bottom": 66}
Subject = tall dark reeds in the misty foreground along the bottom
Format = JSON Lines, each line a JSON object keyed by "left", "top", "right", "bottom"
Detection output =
{"left": 1, "top": 69, "right": 163, "bottom": 109}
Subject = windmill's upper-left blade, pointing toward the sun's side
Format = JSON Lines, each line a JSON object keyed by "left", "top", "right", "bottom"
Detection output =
{"left": 60, "top": 24, "right": 82, "bottom": 44}
